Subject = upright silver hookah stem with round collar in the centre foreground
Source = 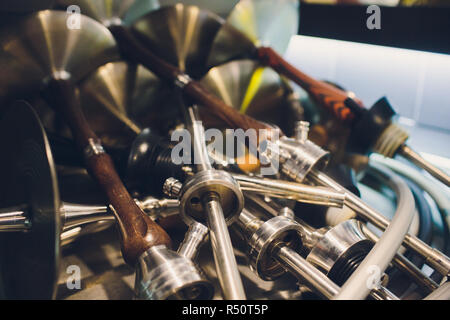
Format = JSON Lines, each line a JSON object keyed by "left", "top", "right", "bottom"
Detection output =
{"left": 171, "top": 107, "right": 245, "bottom": 300}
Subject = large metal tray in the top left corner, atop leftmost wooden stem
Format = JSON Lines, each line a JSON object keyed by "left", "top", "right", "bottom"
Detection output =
{"left": 0, "top": 10, "right": 118, "bottom": 105}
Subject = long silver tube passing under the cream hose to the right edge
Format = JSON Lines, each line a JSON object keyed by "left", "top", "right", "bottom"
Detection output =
{"left": 309, "top": 170, "right": 450, "bottom": 276}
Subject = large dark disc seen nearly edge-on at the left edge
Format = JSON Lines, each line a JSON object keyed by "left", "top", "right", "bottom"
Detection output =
{"left": 0, "top": 101, "right": 61, "bottom": 299}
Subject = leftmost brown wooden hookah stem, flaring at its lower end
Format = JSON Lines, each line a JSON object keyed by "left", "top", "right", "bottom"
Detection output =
{"left": 44, "top": 79, "right": 170, "bottom": 265}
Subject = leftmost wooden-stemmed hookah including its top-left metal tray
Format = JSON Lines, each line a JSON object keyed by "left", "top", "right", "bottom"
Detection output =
{"left": 0, "top": 11, "right": 214, "bottom": 298}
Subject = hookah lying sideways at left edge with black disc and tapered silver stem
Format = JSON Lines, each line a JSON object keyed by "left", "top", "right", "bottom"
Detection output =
{"left": 0, "top": 101, "right": 178, "bottom": 299}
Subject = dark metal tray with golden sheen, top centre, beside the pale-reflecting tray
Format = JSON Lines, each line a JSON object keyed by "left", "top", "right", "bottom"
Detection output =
{"left": 132, "top": 3, "right": 224, "bottom": 77}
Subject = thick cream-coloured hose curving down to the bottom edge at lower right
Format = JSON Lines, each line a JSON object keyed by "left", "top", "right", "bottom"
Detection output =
{"left": 334, "top": 166, "right": 414, "bottom": 300}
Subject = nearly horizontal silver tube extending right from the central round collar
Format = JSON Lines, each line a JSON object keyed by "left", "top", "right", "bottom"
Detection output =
{"left": 233, "top": 174, "right": 345, "bottom": 208}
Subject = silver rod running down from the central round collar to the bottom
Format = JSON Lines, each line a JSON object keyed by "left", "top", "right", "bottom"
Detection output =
{"left": 203, "top": 192, "right": 246, "bottom": 300}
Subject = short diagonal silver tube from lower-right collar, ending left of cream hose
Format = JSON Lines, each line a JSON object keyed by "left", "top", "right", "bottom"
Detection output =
{"left": 273, "top": 246, "right": 339, "bottom": 299}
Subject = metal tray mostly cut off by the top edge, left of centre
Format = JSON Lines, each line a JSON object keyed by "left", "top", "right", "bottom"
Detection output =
{"left": 56, "top": 0, "right": 159, "bottom": 26}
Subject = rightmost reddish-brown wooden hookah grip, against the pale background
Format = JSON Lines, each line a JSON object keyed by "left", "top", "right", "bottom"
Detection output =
{"left": 257, "top": 47, "right": 364, "bottom": 123}
